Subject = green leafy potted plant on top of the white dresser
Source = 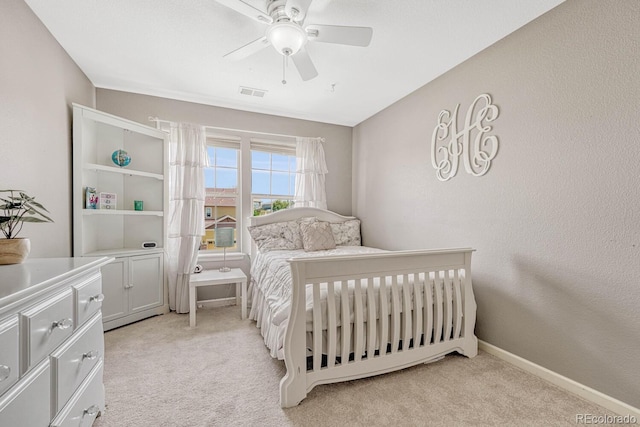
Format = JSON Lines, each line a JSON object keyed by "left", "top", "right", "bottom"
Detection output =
{"left": 0, "top": 190, "right": 53, "bottom": 264}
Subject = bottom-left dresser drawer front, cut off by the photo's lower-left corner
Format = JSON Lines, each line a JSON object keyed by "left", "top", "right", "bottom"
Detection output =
{"left": 0, "top": 360, "right": 51, "bottom": 427}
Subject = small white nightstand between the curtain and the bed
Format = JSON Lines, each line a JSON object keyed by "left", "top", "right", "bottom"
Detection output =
{"left": 189, "top": 268, "right": 247, "bottom": 328}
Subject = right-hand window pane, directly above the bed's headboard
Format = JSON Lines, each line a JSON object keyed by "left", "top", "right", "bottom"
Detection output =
{"left": 251, "top": 147, "right": 296, "bottom": 216}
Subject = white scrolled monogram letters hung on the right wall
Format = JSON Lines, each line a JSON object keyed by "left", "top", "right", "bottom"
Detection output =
{"left": 431, "top": 93, "right": 498, "bottom": 181}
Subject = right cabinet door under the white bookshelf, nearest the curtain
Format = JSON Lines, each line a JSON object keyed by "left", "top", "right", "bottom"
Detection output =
{"left": 129, "top": 253, "right": 164, "bottom": 313}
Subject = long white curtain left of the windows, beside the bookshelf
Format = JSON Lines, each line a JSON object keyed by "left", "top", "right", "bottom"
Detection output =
{"left": 167, "top": 123, "right": 209, "bottom": 313}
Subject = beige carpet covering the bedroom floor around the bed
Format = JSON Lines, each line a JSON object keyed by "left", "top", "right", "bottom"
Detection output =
{"left": 94, "top": 306, "right": 610, "bottom": 427}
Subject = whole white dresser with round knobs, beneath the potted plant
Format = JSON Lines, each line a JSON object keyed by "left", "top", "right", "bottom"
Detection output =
{"left": 0, "top": 257, "right": 112, "bottom": 427}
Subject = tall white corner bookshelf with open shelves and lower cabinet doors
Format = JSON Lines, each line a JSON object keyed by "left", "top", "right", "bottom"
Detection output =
{"left": 73, "top": 104, "right": 169, "bottom": 330}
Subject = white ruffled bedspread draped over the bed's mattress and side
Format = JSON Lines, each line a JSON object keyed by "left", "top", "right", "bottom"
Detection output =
{"left": 249, "top": 246, "right": 384, "bottom": 359}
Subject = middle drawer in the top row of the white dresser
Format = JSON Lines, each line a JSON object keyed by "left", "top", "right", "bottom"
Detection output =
{"left": 20, "top": 289, "right": 73, "bottom": 374}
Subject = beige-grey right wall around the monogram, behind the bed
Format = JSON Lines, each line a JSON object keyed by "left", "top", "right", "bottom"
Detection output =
{"left": 353, "top": 0, "right": 640, "bottom": 407}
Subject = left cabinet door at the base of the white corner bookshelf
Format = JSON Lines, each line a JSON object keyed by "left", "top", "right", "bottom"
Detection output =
{"left": 102, "top": 258, "right": 129, "bottom": 322}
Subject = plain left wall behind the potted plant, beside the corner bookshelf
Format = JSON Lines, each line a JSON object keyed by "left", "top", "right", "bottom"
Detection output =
{"left": 0, "top": 0, "right": 95, "bottom": 257}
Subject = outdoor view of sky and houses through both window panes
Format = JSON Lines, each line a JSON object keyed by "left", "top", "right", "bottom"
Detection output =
{"left": 200, "top": 140, "right": 296, "bottom": 251}
